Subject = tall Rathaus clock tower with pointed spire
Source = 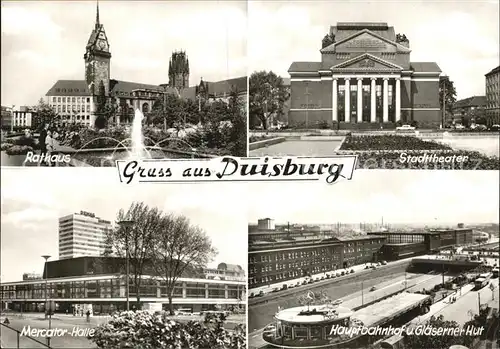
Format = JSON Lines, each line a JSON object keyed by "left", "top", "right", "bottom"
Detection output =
{"left": 83, "top": 1, "right": 111, "bottom": 96}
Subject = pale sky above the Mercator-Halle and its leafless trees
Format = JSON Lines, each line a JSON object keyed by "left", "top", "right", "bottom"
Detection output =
{"left": 0, "top": 168, "right": 248, "bottom": 281}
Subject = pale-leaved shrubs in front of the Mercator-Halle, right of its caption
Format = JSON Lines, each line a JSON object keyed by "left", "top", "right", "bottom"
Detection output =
{"left": 88, "top": 311, "right": 246, "bottom": 349}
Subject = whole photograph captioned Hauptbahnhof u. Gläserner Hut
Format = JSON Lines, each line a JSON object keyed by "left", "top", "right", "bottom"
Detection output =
{"left": 248, "top": 170, "right": 499, "bottom": 349}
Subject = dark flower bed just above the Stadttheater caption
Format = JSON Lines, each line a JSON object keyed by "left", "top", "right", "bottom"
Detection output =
{"left": 340, "top": 135, "right": 452, "bottom": 150}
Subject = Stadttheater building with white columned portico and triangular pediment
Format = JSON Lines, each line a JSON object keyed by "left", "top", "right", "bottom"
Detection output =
{"left": 288, "top": 23, "right": 441, "bottom": 129}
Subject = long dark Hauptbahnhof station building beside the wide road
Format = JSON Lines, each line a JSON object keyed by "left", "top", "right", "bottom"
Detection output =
{"left": 248, "top": 219, "right": 474, "bottom": 289}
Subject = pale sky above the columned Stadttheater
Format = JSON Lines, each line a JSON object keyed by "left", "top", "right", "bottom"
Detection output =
{"left": 248, "top": 0, "right": 500, "bottom": 100}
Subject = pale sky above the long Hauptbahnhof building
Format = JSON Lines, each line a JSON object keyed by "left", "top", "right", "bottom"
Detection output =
{"left": 248, "top": 170, "right": 499, "bottom": 227}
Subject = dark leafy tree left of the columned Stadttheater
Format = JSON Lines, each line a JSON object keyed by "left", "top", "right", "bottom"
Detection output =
{"left": 249, "top": 71, "right": 290, "bottom": 129}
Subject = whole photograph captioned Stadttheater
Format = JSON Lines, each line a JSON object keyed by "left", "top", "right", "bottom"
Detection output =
{"left": 248, "top": 1, "right": 500, "bottom": 170}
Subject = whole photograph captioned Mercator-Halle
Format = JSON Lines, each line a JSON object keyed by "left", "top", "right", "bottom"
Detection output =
{"left": 0, "top": 168, "right": 247, "bottom": 349}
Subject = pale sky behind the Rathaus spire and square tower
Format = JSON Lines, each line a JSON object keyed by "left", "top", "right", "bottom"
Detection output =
{"left": 1, "top": 0, "right": 247, "bottom": 106}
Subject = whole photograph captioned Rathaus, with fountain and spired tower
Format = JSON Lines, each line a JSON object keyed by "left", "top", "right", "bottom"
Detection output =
{"left": 1, "top": 0, "right": 248, "bottom": 167}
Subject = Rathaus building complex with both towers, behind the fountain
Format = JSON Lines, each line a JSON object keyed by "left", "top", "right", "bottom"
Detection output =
{"left": 45, "top": 4, "right": 247, "bottom": 127}
